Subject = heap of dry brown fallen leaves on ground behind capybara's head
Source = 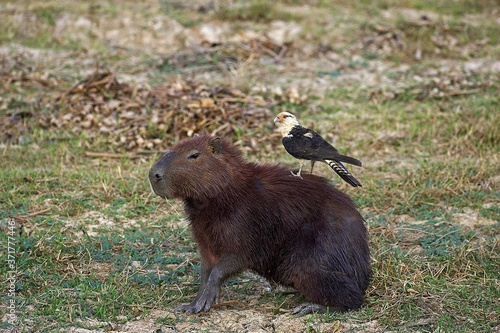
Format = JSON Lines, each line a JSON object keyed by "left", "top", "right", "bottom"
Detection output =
{"left": 0, "top": 39, "right": 297, "bottom": 151}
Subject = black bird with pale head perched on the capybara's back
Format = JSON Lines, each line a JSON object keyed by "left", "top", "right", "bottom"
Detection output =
{"left": 274, "top": 112, "right": 362, "bottom": 187}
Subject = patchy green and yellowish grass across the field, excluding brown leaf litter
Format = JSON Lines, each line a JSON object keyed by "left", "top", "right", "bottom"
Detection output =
{"left": 0, "top": 0, "right": 500, "bottom": 332}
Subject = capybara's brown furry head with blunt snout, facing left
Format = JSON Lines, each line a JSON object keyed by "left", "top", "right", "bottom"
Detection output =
{"left": 149, "top": 135, "right": 242, "bottom": 199}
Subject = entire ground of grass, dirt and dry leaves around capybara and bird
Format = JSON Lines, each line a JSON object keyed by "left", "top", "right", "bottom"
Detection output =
{"left": 0, "top": 0, "right": 500, "bottom": 333}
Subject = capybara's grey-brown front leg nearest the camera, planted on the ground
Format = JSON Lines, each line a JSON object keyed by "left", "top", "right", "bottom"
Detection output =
{"left": 176, "top": 254, "right": 245, "bottom": 314}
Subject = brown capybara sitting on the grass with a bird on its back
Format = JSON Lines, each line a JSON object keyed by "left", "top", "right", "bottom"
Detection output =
{"left": 149, "top": 135, "right": 370, "bottom": 314}
